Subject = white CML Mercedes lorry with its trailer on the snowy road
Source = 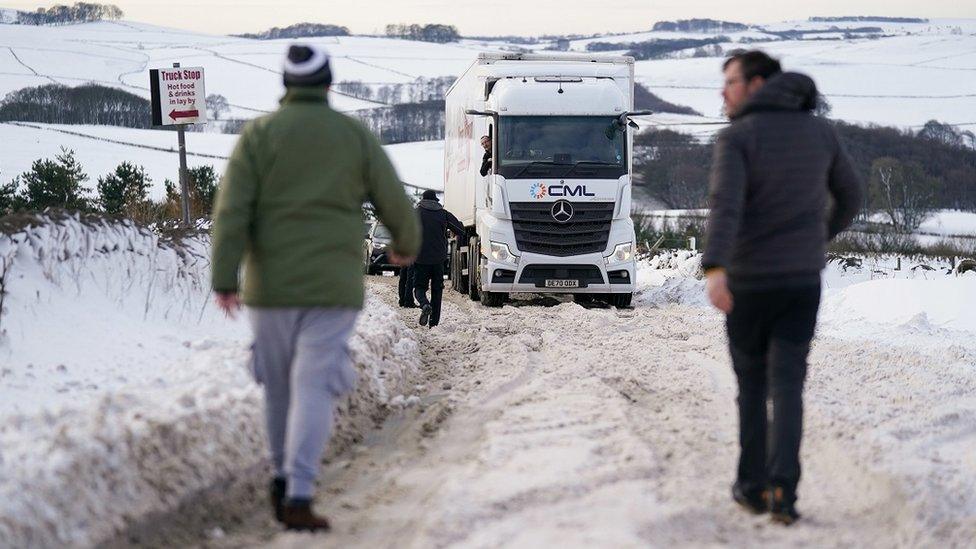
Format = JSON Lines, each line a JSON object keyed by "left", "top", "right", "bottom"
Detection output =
{"left": 444, "top": 53, "right": 648, "bottom": 306}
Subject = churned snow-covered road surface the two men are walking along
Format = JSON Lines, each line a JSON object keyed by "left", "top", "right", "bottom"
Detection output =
{"left": 181, "top": 279, "right": 976, "bottom": 547}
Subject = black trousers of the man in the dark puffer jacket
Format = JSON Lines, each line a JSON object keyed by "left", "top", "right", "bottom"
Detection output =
{"left": 726, "top": 281, "right": 820, "bottom": 497}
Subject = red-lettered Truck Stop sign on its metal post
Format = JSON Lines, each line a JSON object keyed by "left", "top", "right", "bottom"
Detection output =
{"left": 149, "top": 63, "right": 207, "bottom": 226}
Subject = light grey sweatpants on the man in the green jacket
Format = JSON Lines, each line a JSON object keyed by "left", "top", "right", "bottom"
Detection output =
{"left": 248, "top": 307, "right": 359, "bottom": 498}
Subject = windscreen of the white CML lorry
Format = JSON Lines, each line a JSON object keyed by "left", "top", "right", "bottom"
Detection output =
{"left": 496, "top": 116, "right": 627, "bottom": 179}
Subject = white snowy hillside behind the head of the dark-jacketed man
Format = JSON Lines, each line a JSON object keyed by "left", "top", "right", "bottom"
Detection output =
{"left": 572, "top": 19, "right": 976, "bottom": 130}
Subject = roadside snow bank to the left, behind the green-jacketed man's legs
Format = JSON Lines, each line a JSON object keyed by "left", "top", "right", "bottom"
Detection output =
{"left": 0, "top": 214, "right": 419, "bottom": 547}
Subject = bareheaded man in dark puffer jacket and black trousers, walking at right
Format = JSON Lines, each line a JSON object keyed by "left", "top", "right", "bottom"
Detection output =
{"left": 702, "top": 51, "right": 864, "bottom": 524}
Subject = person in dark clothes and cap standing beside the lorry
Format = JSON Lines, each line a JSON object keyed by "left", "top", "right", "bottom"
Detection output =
{"left": 413, "top": 190, "right": 465, "bottom": 328}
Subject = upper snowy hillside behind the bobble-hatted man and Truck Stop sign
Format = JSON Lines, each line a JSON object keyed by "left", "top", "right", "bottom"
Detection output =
{"left": 0, "top": 21, "right": 492, "bottom": 118}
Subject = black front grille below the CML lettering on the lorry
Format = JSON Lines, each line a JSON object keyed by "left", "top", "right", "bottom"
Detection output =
{"left": 509, "top": 202, "right": 615, "bottom": 257}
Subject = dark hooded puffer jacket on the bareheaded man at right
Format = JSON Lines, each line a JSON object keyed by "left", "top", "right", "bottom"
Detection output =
{"left": 702, "top": 73, "right": 864, "bottom": 285}
